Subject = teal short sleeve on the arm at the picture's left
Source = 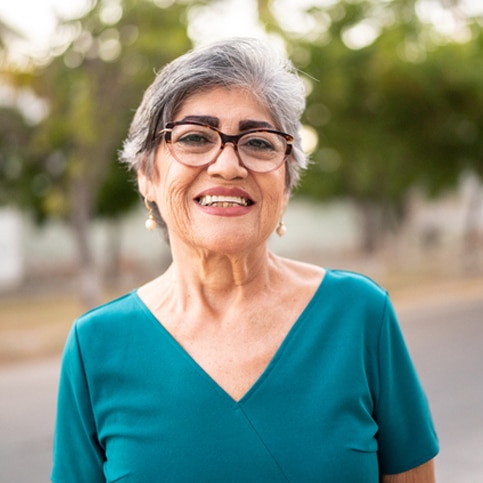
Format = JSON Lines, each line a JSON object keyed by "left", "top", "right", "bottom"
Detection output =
{"left": 51, "top": 325, "right": 106, "bottom": 483}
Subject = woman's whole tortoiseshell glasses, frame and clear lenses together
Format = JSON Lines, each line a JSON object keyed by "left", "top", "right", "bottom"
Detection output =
{"left": 160, "top": 121, "right": 293, "bottom": 173}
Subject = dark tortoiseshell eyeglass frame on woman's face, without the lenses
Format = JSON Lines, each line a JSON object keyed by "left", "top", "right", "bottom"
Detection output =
{"left": 158, "top": 120, "right": 294, "bottom": 174}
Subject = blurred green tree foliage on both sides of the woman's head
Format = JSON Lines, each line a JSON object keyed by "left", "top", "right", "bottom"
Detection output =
{"left": 0, "top": 0, "right": 483, "bottom": 280}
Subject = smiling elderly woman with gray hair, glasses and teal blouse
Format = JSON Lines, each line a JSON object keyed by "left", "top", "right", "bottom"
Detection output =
{"left": 52, "top": 39, "right": 438, "bottom": 483}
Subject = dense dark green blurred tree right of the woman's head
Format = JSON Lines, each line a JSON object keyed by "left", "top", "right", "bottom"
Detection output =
{"left": 264, "top": 0, "right": 483, "bottom": 255}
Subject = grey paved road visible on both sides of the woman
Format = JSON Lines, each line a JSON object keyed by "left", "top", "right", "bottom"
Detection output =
{"left": 0, "top": 294, "right": 483, "bottom": 483}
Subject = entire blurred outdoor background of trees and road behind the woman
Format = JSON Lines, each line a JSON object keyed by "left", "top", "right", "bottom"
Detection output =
{"left": 0, "top": 0, "right": 483, "bottom": 483}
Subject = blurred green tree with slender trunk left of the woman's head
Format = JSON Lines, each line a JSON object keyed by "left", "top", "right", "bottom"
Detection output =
{"left": 24, "top": 0, "right": 195, "bottom": 305}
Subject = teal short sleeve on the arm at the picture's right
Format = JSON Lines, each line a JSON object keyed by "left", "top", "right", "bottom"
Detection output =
{"left": 375, "top": 299, "right": 439, "bottom": 474}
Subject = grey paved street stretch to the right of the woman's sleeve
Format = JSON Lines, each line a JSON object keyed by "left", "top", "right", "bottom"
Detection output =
{"left": 400, "top": 294, "right": 483, "bottom": 483}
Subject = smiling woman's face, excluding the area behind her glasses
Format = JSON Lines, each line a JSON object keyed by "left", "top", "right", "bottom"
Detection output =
{"left": 139, "top": 88, "right": 288, "bottom": 253}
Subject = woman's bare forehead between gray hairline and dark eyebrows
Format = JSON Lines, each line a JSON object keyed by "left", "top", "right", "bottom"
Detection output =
{"left": 173, "top": 87, "right": 274, "bottom": 126}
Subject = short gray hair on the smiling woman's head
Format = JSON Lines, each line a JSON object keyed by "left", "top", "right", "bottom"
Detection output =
{"left": 119, "top": 38, "right": 307, "bottom": 190}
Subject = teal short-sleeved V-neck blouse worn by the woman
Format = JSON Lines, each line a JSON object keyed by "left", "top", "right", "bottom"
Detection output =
{"left": 52, "top": 271, "right": 438, "bottom": 483}
